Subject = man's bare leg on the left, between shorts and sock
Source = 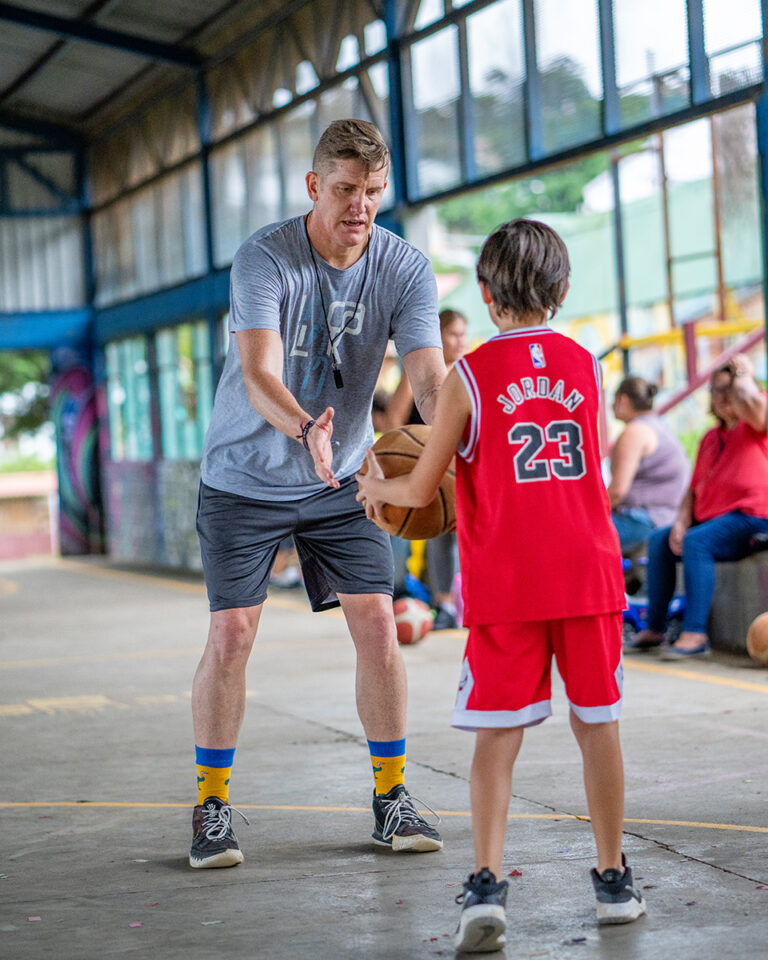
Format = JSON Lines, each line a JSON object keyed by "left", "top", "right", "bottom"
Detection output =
{"left": 192, "top": 605, "right": 261, "bottom": 750}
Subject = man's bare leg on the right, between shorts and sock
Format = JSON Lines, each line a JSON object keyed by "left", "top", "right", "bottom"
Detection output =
{"left": 339, "top": 593, "right": 408, "bottom": 741}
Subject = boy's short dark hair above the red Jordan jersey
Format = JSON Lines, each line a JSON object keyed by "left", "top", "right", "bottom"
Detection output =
{"left": 477, "top": 219, "right": 571, "bottom": 318}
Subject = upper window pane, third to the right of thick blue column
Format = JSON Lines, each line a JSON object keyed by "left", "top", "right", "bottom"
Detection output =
{"left": 534, "top": 0, "right": 603, "bottom": 153}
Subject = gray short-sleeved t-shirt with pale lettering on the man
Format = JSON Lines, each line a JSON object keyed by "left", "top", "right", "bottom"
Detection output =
{"left": 201, "top": 217, "right": 441, "bottom": 500}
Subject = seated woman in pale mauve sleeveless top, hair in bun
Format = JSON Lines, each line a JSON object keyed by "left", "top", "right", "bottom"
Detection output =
{"left": 608, "top": 377, "right": 691, "bottom": 554}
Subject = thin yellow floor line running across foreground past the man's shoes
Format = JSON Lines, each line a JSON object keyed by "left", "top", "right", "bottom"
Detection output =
{"left": 0, "top": 800, "right": 768, "bottom": 833}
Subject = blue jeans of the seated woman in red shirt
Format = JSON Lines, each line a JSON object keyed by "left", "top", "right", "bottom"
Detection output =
{"left": 648, "top": 510, "right": 768, "bottom": 633}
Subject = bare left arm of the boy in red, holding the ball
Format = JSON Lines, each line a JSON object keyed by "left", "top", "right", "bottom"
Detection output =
{"left": 357, "top": 369, "right": 472, "bottom": 519}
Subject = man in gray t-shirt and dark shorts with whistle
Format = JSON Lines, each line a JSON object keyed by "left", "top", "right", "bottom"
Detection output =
{"left": 190, "top": 120, "right": 445, "bottom": 867}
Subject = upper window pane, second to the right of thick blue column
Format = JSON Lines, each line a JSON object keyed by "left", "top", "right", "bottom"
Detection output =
{"left": 467, "top": 0, "right": 526, "bottom": 176}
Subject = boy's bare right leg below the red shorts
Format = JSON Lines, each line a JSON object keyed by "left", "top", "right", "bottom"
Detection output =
{"left": 571, "top": 710, "right": 624, "bottom": 873}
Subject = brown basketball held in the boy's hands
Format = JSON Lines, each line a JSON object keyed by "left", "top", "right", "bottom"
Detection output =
{"left": 360, "top": 423, "right": 456, "bottom": 540}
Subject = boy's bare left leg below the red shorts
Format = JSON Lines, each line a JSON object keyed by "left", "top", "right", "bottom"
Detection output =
{"left": 469, "top": 727, "right": 524, "bottom": 880}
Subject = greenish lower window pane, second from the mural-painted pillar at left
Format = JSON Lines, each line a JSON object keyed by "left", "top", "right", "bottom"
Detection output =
{"left": 156, "top": 320, "right": 213, "bottom": 460}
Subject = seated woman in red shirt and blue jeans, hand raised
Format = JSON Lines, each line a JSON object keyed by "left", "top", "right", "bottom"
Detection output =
{"left": 625, "top": 354, "right": 768, "bottom": 660}
